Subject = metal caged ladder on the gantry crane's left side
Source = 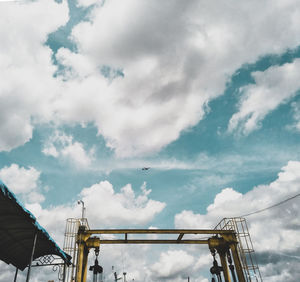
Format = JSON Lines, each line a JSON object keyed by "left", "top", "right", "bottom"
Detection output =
{"left": 63, "top": 218, "right": 90, "bottom": 282}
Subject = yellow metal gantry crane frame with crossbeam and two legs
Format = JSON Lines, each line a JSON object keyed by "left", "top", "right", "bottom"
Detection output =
{"left": 75, "top": 225, "right": 246, "bottom": 282}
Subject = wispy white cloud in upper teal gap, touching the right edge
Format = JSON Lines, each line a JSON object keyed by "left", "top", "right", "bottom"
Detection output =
{"left": 228, "top": 59, "right": 300, "bottom": 134}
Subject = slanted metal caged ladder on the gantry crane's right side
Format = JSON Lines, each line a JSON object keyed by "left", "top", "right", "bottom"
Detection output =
{"left": 215, "top": 217, "right": 263, "bottom": 282}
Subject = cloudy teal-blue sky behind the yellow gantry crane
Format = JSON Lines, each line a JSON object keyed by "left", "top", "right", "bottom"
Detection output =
{"left": 0, "top": 0, "right": 300, "bottom": 282}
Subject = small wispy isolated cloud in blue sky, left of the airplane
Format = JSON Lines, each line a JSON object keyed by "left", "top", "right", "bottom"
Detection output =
{"left": 42, "top": 130, "right": 94, "bottom": 168}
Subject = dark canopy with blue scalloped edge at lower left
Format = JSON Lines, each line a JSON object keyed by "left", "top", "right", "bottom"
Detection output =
{"left": 0, "top": 180, "right": 71, "bottom": 270}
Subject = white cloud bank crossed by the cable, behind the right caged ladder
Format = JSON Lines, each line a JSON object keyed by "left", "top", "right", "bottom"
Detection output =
{"left": 175, "top": 161, "right": 300, "bottom": 281}
